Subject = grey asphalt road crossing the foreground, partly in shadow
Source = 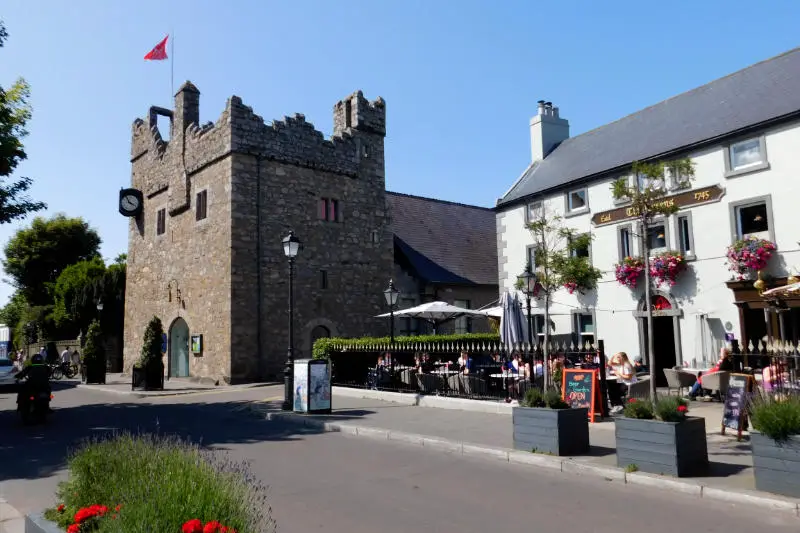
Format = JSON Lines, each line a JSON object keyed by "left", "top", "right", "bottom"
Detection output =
{"left": 0, "top": 387, "right": 800, "bottom": 533}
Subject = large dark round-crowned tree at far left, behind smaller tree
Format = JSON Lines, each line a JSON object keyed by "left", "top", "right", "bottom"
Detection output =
{"left": 3, "top": 214, "right": 101, "bottom": 306}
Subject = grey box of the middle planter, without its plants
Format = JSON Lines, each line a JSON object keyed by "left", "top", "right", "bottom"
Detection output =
{"left": 614, "top": 417, "right": 708, "bottom": 477}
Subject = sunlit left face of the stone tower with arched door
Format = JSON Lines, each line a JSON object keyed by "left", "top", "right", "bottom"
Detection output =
{"left": 124, "top": 86, "right": 231, "bottom": 380}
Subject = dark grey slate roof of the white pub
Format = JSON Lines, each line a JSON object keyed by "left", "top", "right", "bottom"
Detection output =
{"left": 504, "top": 48, "right": 800, "bottom": 207}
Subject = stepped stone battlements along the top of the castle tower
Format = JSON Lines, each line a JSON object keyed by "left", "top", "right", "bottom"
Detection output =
{"left": 131, "top": 82, "right": 386, "bottom": 183}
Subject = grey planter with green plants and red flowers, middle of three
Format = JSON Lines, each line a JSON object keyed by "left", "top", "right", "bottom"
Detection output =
{"left": 614, "top": 397, "right": 708, "bottom": 477}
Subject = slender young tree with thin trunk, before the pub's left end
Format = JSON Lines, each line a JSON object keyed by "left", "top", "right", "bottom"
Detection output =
{"left": 518, "top": 210, "right": 603, "bottom": 388}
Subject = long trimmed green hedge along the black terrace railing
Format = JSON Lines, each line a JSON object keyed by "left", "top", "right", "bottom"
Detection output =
{"left": 312, "top": 333, "right": 500, "bottom": 359}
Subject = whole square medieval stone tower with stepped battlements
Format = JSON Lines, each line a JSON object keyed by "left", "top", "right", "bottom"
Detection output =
{"left": 124, "top": 82, "right": 393, "bottom": 382}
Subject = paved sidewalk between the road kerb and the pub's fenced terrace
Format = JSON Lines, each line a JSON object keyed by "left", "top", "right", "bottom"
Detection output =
{"left": 254, "top": 394, "right": 785, "bottom": 510}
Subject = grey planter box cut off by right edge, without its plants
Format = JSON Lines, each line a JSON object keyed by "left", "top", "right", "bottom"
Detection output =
{"left": 750, "top": 431, "right": 800, "bottom": 498}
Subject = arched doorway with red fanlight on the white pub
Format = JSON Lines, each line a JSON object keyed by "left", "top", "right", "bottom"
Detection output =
{"left": 634, "top": 290, "right": 683, "bottom": 387}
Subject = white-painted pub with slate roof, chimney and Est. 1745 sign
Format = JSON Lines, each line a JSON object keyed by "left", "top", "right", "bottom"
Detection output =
{"left": 497, "top": 44, "right": 800, "bottom": 374}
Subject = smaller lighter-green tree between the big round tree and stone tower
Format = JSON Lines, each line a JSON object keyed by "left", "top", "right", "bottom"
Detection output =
{"left": 53, "top": 257, "right": 106, "bottom": 337}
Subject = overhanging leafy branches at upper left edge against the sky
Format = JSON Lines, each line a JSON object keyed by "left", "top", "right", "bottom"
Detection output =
{"left": 0, "top": 21, "right": 46, "bottom": 224}
